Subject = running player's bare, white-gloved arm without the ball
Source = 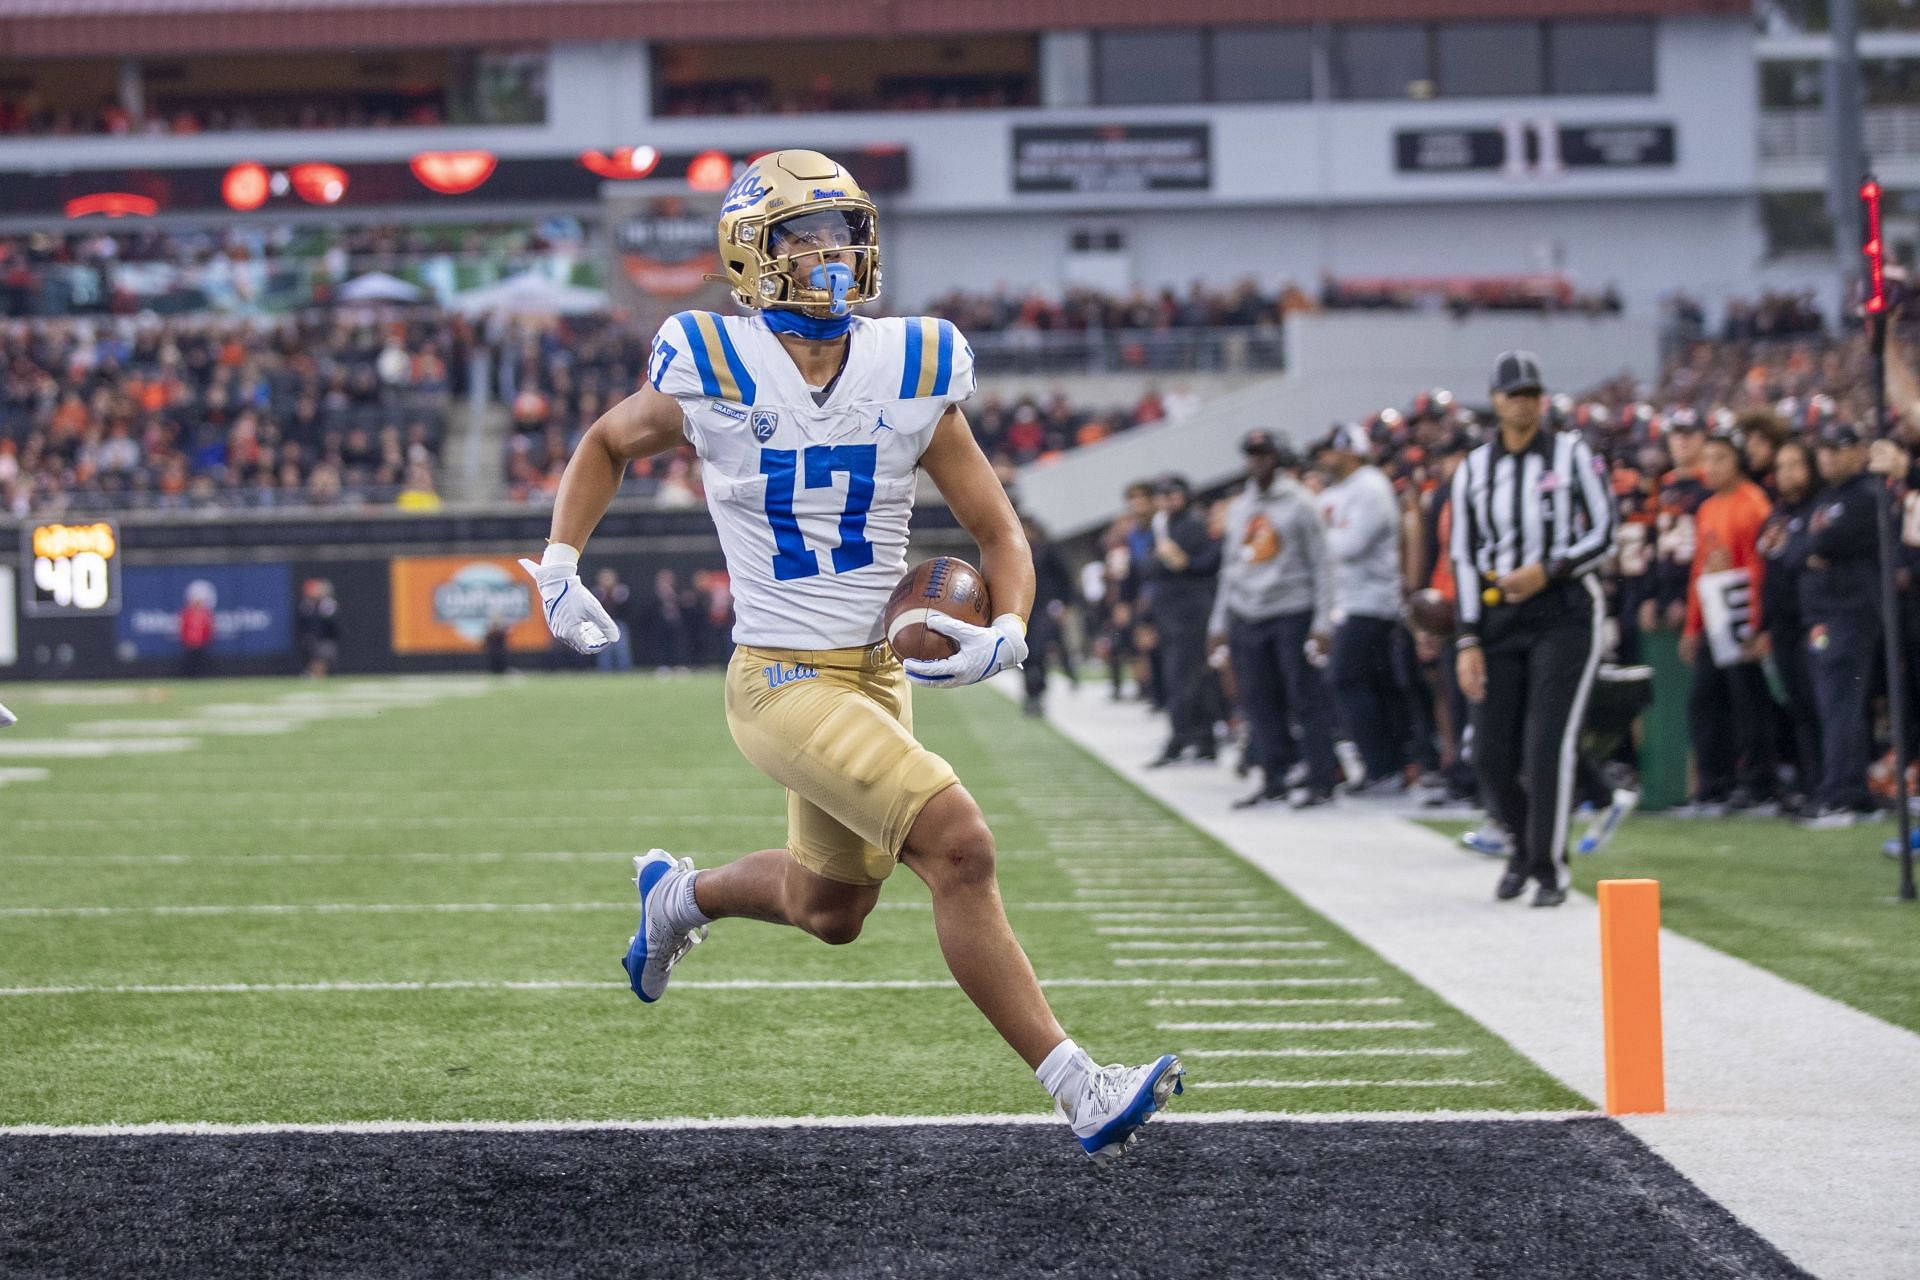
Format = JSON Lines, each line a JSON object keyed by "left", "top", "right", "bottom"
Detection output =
{"left": 520, "top": 388, "right": 687, "bottom": 652}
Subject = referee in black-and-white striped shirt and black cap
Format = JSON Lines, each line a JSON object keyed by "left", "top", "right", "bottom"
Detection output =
{"left": 1450, "top": 351, "right": 1615, "bottom": 906}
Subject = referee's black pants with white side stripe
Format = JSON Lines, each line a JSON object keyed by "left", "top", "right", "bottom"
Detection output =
{"left": 1473, "top": 578, "right": 1601, "bottom": 889}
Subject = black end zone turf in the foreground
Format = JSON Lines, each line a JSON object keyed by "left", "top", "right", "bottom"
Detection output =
{"left": 0, "top": 1121, "right": 1805, "bottom": 1280}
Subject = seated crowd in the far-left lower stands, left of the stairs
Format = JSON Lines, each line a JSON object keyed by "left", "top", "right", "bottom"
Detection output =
{"left": 0, "top": 317, "right": 472, "bottom": 516}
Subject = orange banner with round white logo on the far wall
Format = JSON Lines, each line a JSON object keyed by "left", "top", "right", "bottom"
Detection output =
{"left": 390, "top": 557, "right": 551, "bottom": 652}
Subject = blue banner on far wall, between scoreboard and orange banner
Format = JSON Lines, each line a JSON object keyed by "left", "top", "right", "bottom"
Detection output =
{"left": 115, "top": 564, "right": 294, "bottom": 658}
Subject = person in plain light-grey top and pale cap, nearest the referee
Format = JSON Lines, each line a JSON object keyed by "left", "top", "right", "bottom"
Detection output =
{"left": 1315, "top": 422, "right": 1409, "bottom": 794}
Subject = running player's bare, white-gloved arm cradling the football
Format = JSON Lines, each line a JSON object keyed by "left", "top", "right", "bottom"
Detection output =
{"left": 904, "top": 405, "right": 1033, "bottom": 687}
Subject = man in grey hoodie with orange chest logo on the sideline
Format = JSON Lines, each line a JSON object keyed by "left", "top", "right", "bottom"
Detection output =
{"left": 1208, "top": 432, "right": 1340, "bottom": 808}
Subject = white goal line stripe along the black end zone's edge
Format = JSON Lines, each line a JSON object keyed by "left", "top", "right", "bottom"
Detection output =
{"left": 0, "top": 1113, "right": 1601, "bottom": 1138}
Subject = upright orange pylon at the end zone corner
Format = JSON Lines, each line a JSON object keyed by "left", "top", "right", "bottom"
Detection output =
{"left": 1599, "top": 881, "right": 1667, "bottom": 1115}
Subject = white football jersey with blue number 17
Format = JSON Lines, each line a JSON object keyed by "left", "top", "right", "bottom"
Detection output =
{"left": 647, "top": 311, "right": 973, "bottom": 649}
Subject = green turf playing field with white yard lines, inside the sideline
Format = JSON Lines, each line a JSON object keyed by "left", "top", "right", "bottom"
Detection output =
{"left": 0, "top": 676, "right": 1590, "bottom": 1125}
